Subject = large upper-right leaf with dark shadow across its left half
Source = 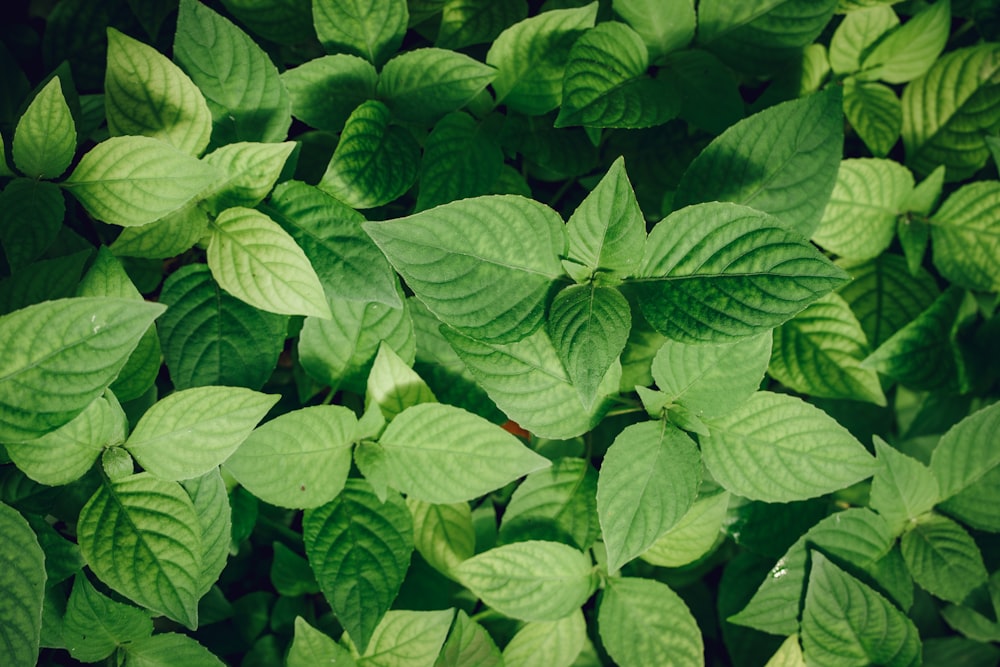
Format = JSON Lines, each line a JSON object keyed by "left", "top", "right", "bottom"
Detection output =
{"left": 674, "top": 86, "right": 843, "bottom": 236}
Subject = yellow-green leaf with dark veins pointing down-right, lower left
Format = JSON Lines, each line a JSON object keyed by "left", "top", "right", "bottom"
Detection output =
{"left": 77, "top": 473, "right": 204, "bottom": 628}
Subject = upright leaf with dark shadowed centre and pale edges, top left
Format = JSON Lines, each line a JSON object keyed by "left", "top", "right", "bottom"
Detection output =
{"left": 104, "top": 28, "right": 212, "bottom": 155}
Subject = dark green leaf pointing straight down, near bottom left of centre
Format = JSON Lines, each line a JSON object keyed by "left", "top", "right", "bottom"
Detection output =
{"left": 302, "top": 479, "right": 413, "bottom": 651}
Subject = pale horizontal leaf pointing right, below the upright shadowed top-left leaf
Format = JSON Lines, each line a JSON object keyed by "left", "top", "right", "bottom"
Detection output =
{"left": 63, "top": 136, "right": 221, "bottom": 227}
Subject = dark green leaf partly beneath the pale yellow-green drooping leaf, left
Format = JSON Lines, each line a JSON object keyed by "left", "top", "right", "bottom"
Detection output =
{"left": 157, "top": 264, "right": 287, "bottom": 389}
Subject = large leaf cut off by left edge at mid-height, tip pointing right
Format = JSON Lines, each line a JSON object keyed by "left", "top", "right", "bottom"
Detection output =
{"left": 0, "top": 297, "right": 166, "bottom": 442}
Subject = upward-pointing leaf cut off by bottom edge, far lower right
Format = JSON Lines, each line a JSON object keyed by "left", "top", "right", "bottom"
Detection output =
{"left": 802, "top": 551, "right": 920, "bottom": 667}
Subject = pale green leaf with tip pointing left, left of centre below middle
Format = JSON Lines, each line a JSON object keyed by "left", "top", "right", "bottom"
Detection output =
{"left": 226, "top": 405, "right": 357, "bottom": 509}
